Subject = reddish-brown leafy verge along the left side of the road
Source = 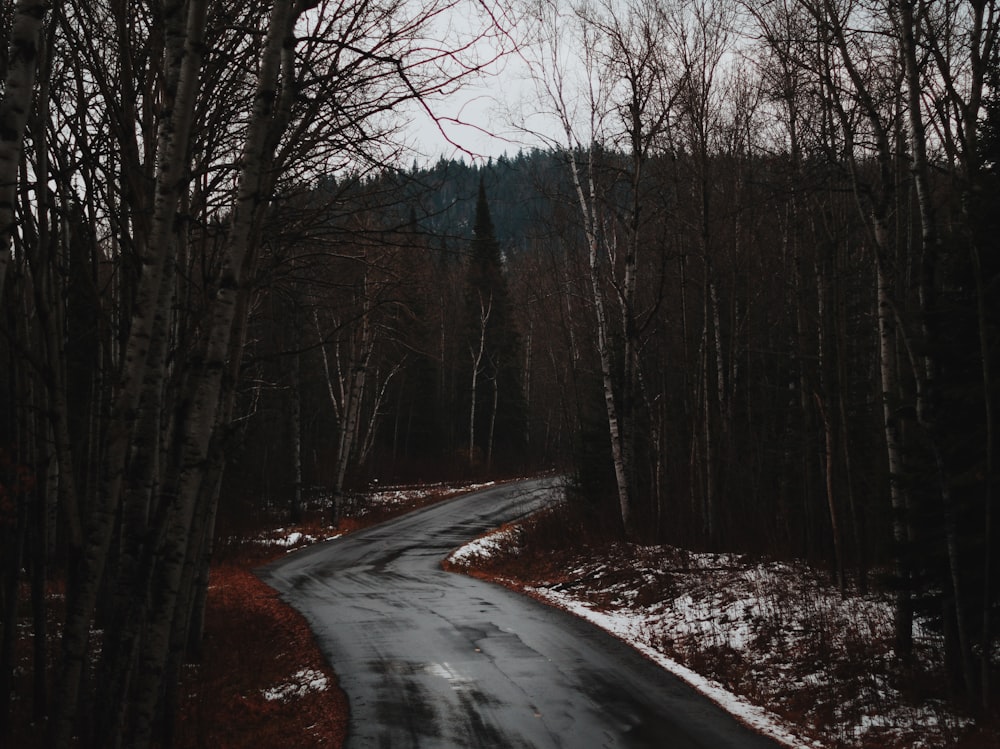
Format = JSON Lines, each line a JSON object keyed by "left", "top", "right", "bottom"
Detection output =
{"left": 0, "top": 485, "right": 488, "bottom": 749}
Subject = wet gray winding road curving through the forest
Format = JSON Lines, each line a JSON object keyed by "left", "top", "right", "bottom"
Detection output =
{"left": 260, "top": 480, "right": 775, "bottom": 749}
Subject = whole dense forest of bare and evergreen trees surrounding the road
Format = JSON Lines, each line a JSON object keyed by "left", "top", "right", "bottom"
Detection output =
{"left": 0, "top": 0, "right": 1000, "bottom": 747}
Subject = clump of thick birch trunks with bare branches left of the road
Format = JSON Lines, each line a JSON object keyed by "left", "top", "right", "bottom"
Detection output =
{"left": 0, "top": 0, "right": 512, "bottom": 747}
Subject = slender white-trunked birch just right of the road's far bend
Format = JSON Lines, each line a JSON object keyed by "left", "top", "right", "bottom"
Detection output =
{"left": 536, "top": 3, "right": 674, "bottom": 538}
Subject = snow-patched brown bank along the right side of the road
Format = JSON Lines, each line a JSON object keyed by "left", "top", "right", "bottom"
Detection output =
{"left": 447, "top": 527, "right": 972, "bottom": 749}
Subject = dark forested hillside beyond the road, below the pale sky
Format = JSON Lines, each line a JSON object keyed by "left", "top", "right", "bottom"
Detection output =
{"left": 229, "top": 124, "right": 997, "bottom": 712}
